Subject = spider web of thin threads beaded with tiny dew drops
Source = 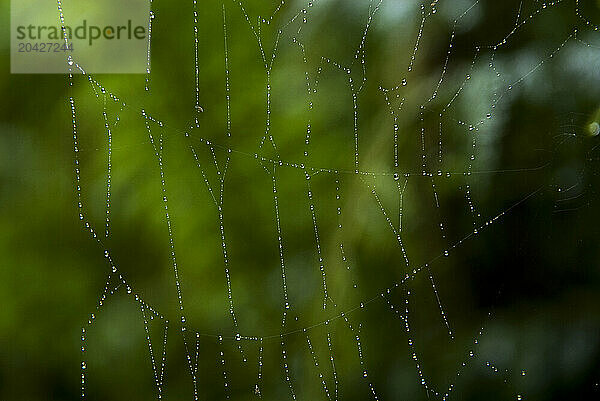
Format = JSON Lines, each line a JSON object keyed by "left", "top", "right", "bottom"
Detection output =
{"left": 58, "top": 0, "right": 599, "bottom": 400}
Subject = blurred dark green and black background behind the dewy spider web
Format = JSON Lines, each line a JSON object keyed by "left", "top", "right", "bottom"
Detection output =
{"left": 0, "top": 0, "right": 600, "bottom": 400}
